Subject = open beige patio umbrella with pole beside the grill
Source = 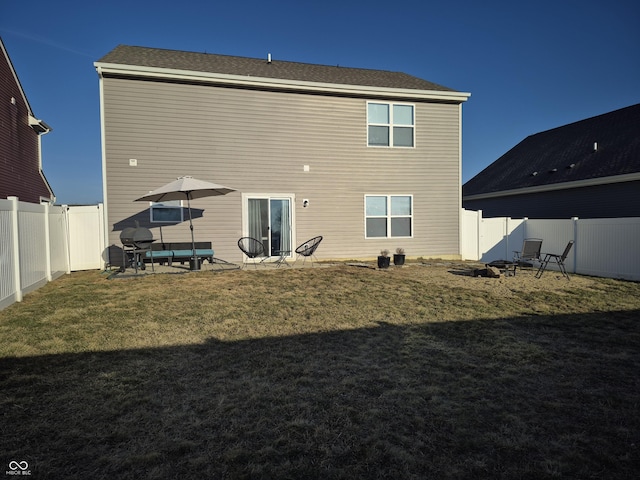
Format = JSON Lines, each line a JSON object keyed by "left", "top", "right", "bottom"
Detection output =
{"left": 135, "top": 176, "right": 235, "bottom": 270}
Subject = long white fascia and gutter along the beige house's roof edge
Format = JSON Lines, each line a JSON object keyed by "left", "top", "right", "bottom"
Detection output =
{"left": 94, "top": 62, "right": 471, "bottom": 103}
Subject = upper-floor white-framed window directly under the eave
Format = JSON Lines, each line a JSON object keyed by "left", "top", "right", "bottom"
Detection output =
{"left": 367, "top": 102, "right": 415, "bottom": 147}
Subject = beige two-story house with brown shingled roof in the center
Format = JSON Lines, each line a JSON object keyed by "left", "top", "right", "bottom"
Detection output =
{"left": 95, "top": 45, "right": 470, "bottom": 264}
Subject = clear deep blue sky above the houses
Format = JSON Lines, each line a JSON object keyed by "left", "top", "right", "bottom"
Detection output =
{"left": 0, "top": 0, "right": 640, "bottom": 204}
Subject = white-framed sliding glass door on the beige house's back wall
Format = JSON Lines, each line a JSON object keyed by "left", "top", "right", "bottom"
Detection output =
{"left": 245, "top": 195, "right": 293, "bottom": 256}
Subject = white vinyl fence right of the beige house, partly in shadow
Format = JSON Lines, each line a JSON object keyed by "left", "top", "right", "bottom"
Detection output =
{"left": 461, "top": 210, "right": 640, "bottom": 281}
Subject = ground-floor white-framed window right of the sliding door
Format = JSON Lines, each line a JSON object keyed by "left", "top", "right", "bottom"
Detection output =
{"left": 364, "top": 195, "right": 413, "bottom": 238}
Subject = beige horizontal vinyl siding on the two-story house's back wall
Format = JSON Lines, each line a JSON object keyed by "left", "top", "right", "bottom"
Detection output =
{"left": 103, "top": 78, "right": 460, "bottom": 261}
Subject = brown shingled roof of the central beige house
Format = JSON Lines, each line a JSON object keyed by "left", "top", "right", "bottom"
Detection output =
{"left": 98, "top": 45, "right": 455, "bottom": 92}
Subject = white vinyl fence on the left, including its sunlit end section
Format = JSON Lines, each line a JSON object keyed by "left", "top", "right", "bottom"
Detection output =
{"left": 0, "top": 197, "right": 104, "bottom": 309}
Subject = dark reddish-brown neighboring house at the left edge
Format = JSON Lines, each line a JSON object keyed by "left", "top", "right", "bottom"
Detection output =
{"left": 0, "top": 39, "right": 55, "bottom": 203}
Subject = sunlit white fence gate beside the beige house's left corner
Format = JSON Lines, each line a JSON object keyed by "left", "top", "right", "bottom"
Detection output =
{"left": 67, "top": 203, "right": 104, "bottom": 272}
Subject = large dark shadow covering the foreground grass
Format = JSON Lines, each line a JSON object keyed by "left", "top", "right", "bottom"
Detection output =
{"left": 0, "top": 311, "right": 640, "bottom": 479}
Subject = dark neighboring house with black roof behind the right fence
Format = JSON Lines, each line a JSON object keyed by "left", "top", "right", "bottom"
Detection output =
{"left": 462, "top": 104, "right": 640, "bottom": 218}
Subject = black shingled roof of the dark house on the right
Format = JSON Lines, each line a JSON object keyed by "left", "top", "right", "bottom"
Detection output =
{"left": 462, "top": 104, "right": 640, "bottom": 197}
